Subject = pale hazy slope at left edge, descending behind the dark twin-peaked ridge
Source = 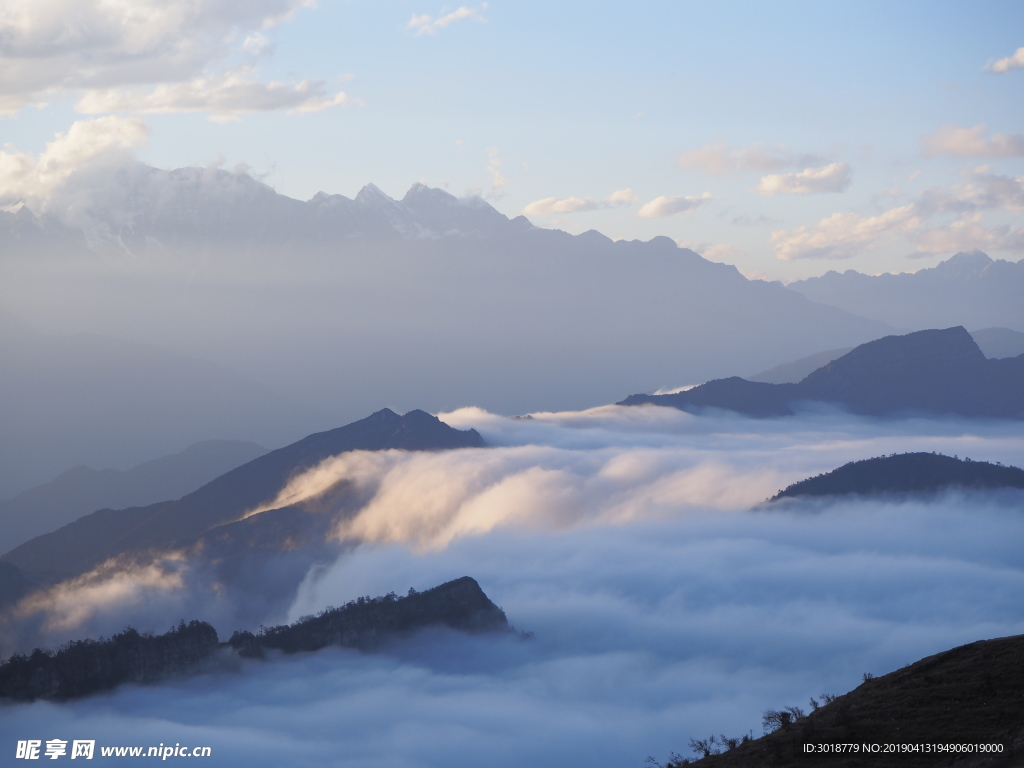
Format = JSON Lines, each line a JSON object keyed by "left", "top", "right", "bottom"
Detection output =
{"left": 0, "top": 312, "right": 326, "bottom": 505}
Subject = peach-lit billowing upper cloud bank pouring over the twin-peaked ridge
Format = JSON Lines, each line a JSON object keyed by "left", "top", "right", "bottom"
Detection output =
{"left": 235, "top": 406, "right": 1024, "bottom": 551}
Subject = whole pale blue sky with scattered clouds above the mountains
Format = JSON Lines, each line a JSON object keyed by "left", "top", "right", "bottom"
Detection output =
{"left": 0, "top": 0, "right": 1024, "bottom": 280}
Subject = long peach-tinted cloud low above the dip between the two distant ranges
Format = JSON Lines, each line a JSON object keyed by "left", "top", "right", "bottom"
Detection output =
{"left": 771, "top": 205, "right": 922, "bottom": 261}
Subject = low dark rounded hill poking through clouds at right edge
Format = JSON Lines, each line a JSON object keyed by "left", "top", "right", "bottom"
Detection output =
{"left": 771, "top": 453, "right": 1024, "bottom": 501}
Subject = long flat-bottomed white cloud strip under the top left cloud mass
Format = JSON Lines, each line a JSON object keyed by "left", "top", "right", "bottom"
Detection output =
{"left": 76, "top": 68, "right": 357, "bottom": 122}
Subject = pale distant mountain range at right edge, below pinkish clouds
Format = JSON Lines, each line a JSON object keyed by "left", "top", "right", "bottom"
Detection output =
{"left": 788, "top": 251, "right": 1024, "bottom": 331}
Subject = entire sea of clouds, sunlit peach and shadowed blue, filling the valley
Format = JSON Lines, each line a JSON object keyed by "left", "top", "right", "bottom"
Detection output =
{"left": 0, "top": 407, "right": 1024, "bottom": 768}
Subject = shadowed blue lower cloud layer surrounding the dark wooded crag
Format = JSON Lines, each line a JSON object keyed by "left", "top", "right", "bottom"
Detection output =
{"left": 8, "top": 497, "right": 1024, "bottom": 768}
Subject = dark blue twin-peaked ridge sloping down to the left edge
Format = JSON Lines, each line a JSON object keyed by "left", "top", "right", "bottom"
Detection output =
{"left": 0, "top": 409, "right": 483, "bottom": 583}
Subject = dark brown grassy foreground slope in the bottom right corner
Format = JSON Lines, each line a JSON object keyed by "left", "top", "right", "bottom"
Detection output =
{"left": 670, "top": 635, "right": 1024, "bottom": 768}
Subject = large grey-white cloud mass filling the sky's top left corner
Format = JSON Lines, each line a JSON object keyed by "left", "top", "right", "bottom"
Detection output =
{"left": 0, "top": 0, "right": 347, "bottom": 116}
